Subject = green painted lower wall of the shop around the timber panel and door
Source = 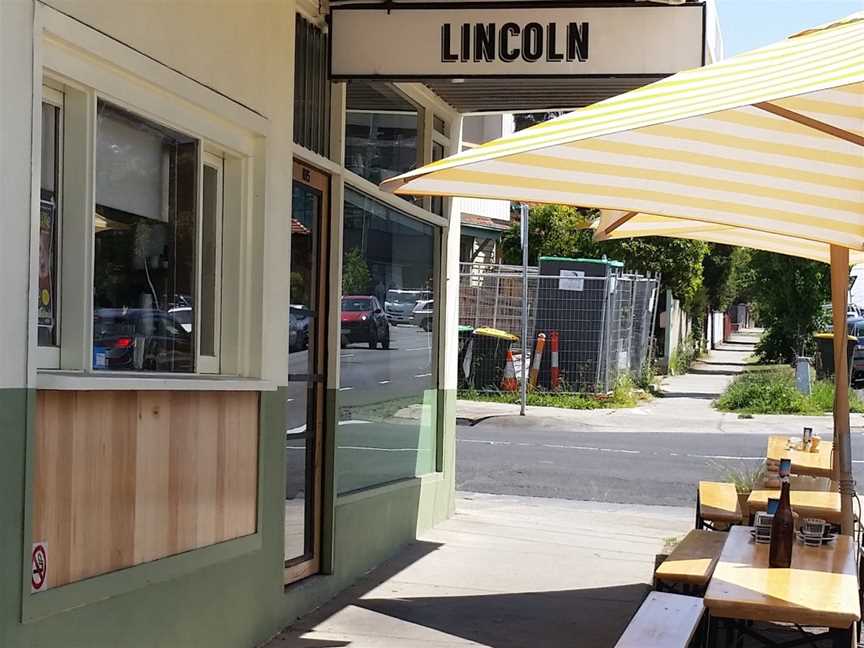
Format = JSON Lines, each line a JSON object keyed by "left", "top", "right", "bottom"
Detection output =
{"left": 0, "top": 389, "right": 455, "bottom": 648}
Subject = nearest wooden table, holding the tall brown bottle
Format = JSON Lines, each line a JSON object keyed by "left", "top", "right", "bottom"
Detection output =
{"left": 704, "top": 526, "right": 861, "bottom": 647}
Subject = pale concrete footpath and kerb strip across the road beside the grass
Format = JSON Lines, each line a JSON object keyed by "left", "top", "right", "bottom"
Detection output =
{"left": 456, "top": 332, "right": 864, "bottom": 436}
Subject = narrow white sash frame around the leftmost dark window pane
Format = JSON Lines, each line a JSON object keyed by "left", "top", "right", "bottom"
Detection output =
{"left": 36, "top": 82, "right": 66, "bottom": 369}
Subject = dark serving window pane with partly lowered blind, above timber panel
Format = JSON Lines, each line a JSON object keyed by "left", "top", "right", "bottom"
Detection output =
{"left": 93, "top": 102, "right": 198, "bottom": 372}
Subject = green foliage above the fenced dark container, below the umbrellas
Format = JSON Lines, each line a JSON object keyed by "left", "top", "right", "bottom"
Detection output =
{"left": 501, "top": 205, "right": 708, "bottom": 312}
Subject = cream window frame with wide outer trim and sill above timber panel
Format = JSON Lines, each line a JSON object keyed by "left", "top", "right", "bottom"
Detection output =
{"left": 29, "top": 3, "right": 270, "bottom": 391}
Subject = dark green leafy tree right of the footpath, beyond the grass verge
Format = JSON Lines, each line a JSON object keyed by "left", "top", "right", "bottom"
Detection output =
{"left": 749, "top": 250, "right": 830, "bottom": 363}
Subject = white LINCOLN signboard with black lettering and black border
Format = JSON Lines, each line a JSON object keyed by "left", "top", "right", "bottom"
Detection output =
{"left": 330, "top": 3, "right": 705, "bottom": 79}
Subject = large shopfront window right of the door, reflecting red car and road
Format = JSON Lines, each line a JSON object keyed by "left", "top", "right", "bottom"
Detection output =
{"left": 336, "top": 189, "right": 439, "bottom": 493}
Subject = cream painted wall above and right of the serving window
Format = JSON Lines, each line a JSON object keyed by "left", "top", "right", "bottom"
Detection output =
{"left": 39, "top": 0, "right": 295, "bottom": 384}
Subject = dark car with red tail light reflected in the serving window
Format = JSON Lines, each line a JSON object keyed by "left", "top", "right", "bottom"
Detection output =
{"left": 93, "top": 308, "right": 195, "bottom": 372}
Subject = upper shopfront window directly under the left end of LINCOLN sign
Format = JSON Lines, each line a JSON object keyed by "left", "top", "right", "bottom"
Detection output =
{"left": 345, "top": 81, "right": 422, "bottom": 184}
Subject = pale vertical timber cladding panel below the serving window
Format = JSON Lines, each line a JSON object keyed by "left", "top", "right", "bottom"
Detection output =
{"left": 33, "top": 391, "right": 259, "bottom": 587}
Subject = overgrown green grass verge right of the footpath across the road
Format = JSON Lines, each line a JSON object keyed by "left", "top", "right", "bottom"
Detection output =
{"left": 714, "top": 367, "right": 864, "bottom": 415}
